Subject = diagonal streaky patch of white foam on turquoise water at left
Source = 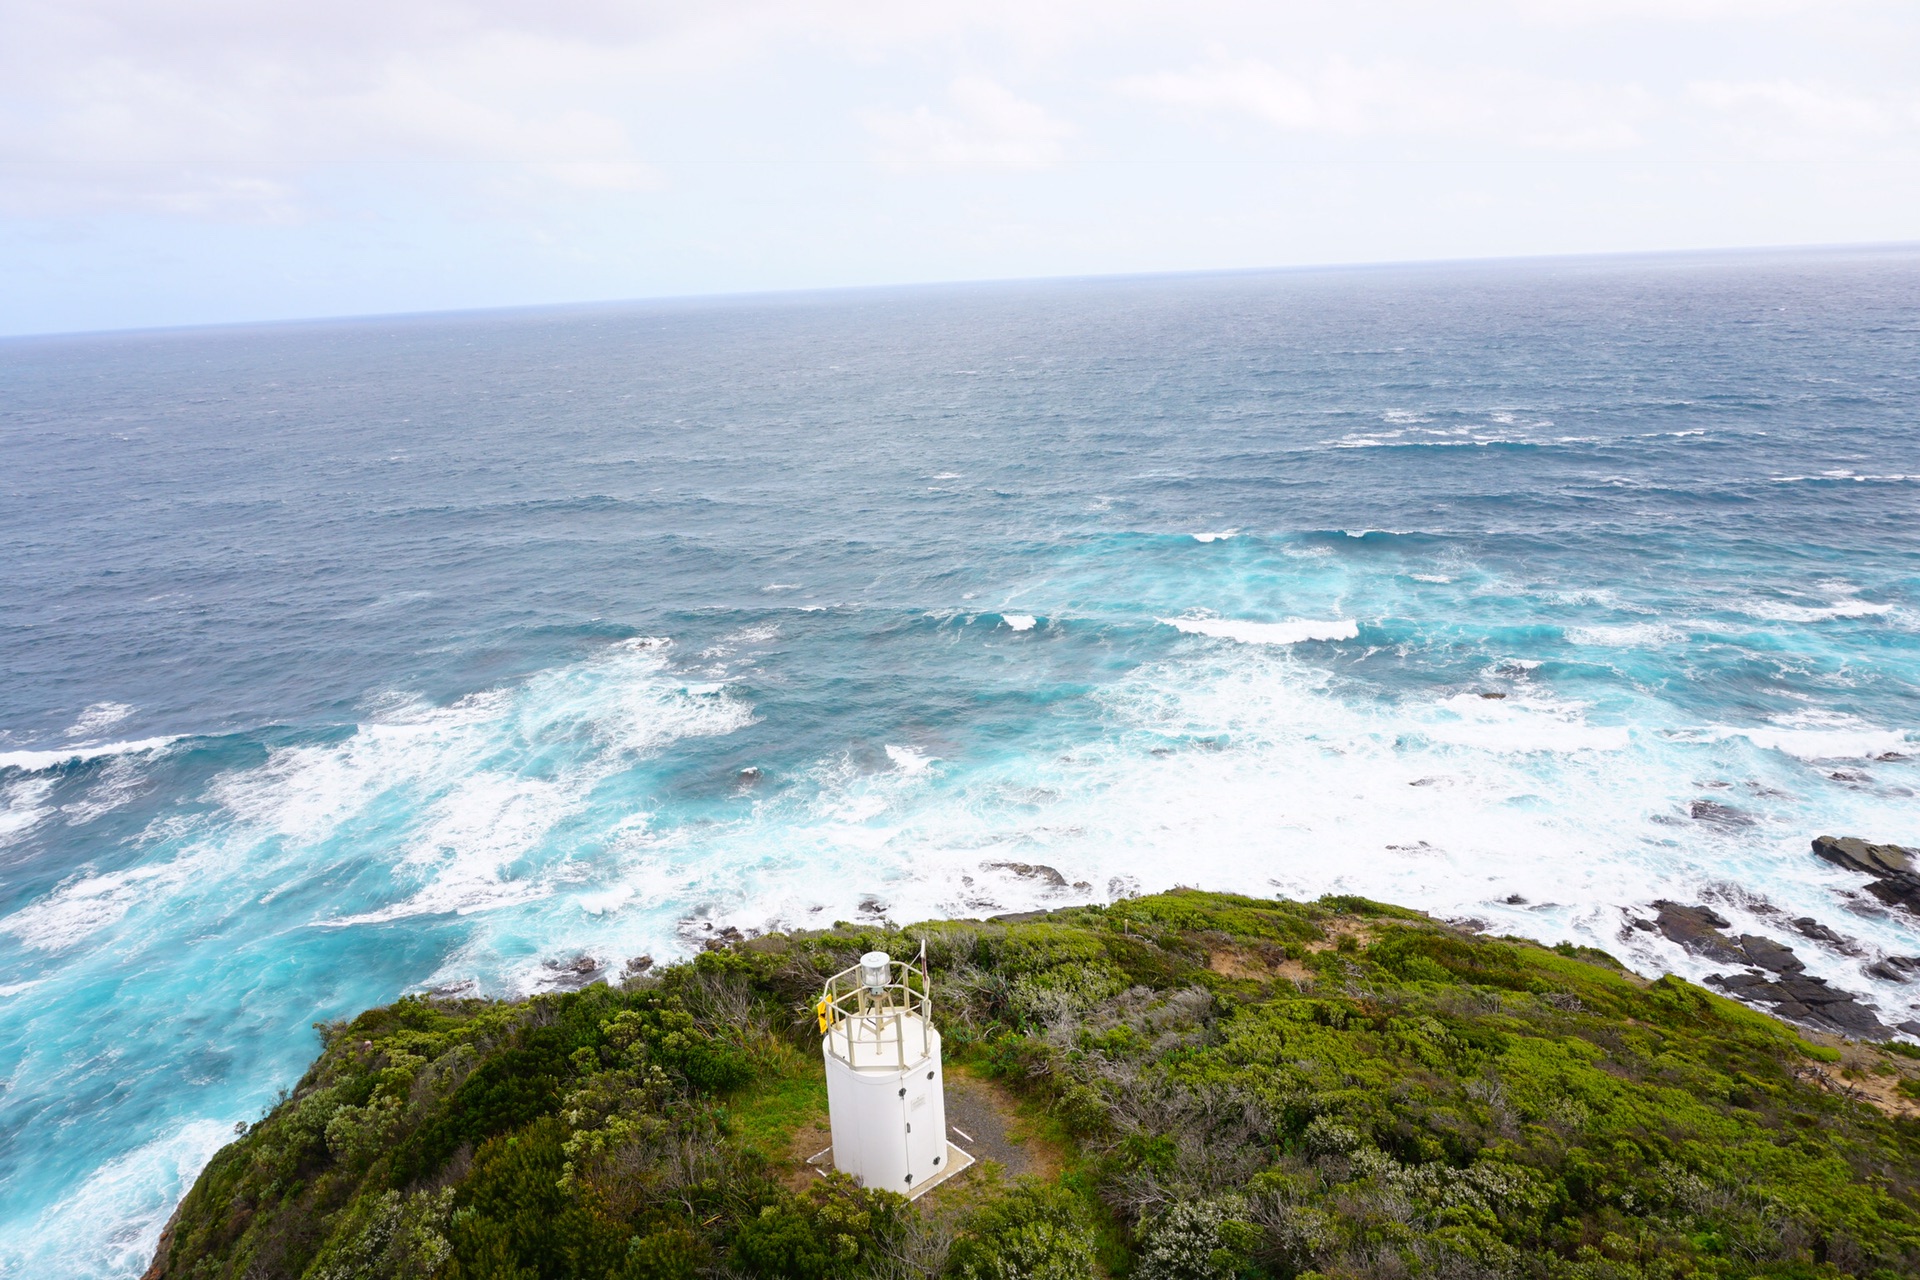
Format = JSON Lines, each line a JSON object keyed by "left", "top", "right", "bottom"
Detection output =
{"left": 0, "top": 637, "right": 753, "bottom": 952}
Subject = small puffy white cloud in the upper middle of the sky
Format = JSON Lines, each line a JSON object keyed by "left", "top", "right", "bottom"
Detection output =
{"left": 866, "top": 77, "right": 1075, "bottom": 169}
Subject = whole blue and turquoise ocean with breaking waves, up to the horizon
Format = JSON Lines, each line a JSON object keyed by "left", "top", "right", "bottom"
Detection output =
{"left": 0, "top": 251, "right": 1920, "bottom": 1276}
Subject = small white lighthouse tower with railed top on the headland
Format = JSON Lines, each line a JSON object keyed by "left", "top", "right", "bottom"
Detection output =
{"left": 816, "top": 944, "right": 973, "bottom": 1199}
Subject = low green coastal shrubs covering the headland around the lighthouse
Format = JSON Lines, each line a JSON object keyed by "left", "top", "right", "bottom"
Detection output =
{"left": 150, "top": 890, "right": 1920, "bottom": 1280}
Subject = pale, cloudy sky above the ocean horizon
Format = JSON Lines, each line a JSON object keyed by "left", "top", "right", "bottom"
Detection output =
{"left": 0, "top": 0, "right": 1920, "bottom": 334}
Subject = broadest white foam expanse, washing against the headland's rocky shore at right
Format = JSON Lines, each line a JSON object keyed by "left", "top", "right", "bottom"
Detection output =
{"left": 591, "top": 647, "right": 1910, "bottom": 1019}
